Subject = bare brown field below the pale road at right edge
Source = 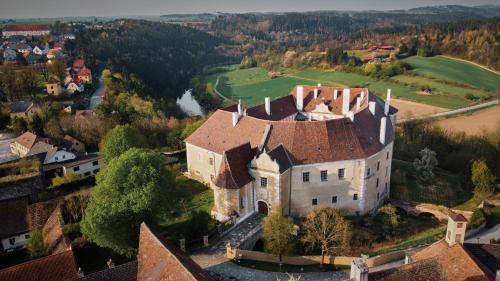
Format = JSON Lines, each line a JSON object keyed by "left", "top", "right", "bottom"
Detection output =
{"left": 436, "top": 106, "right": 500, "bottom": 135}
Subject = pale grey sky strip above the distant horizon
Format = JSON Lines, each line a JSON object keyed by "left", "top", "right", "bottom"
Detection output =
{"left": 0, "top": 0, "right": 500, "bottom": 18}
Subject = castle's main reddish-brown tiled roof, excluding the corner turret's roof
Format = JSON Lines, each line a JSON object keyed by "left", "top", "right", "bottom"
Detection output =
{"left": 186, "top": 88, "right": 396, "bottom": 165}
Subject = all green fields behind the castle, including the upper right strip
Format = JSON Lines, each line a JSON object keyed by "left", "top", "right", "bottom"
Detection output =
{"left": 206, "top": 57, "right": 500, "bottom": 108}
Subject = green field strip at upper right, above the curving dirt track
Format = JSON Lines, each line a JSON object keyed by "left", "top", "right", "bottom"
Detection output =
{"left": 405, "top": 56, "right": 500, "bottom": 91}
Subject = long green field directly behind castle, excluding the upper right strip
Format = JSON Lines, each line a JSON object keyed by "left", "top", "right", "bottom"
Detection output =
{"left": 206, "top": 63, "right": 494, "bottom": 108}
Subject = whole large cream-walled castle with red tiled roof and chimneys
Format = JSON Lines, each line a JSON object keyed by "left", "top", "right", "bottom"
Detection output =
{"left": 186, "top": 84, "right": 397, "bottom": 221}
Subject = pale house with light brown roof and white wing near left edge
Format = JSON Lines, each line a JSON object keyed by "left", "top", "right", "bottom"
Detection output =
{"left": 10, "top": 132, "right": 76, "bottom": 164}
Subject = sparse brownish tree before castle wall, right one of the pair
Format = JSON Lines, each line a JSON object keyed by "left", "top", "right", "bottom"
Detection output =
{"left": 302, "top": 207, "right": 351, "bottom": 268}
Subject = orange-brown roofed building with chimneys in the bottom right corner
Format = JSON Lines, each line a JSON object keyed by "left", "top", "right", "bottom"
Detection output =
{"left": 350, "top": 213, "right": 500, "bottom": 281}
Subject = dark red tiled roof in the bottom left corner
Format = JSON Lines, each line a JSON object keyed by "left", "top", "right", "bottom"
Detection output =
{"left": 0, "top": 249, "right": 78, "bottom": 281}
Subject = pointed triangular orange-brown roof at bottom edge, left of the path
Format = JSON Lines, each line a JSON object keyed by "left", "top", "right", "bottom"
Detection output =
{"left": 137, "top": 223, "right": 215, "bottom": 281}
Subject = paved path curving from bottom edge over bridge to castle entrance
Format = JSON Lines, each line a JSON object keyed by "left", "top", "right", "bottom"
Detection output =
{"left": 191, "top": 214, "right": 349, "bottom": 281}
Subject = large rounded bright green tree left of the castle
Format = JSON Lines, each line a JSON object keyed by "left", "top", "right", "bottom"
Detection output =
{"left": 81, "top": 148, "right": 176, "bottom": 257}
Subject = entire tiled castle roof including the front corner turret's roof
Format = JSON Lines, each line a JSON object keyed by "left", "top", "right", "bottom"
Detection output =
{"left": 186, "top": 86, "right": 396, "bottom": 188}
